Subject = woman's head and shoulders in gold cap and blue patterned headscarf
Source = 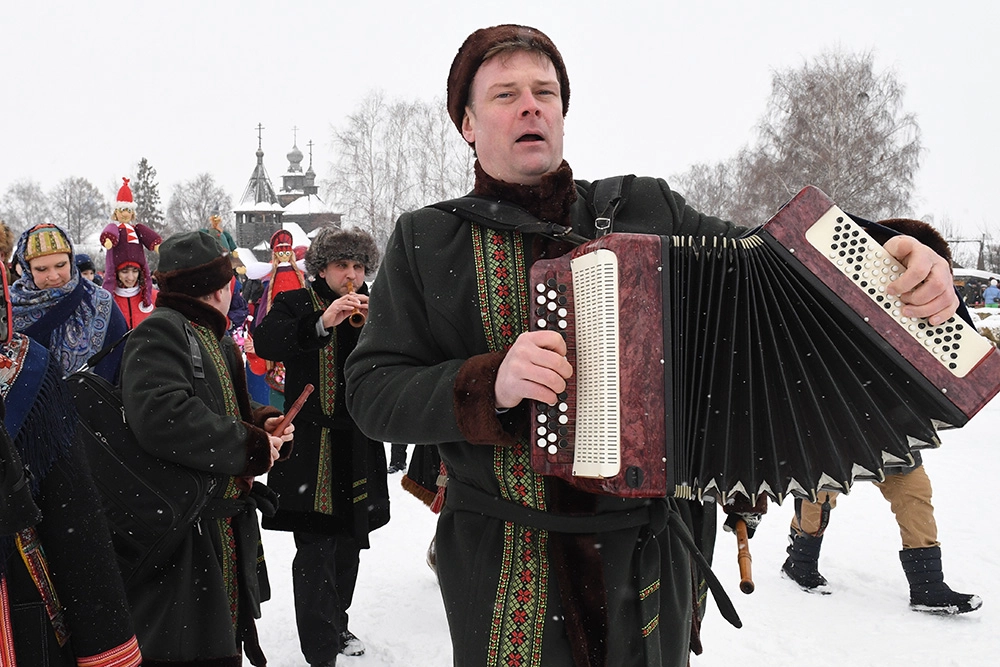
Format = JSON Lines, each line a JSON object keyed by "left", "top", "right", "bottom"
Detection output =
{"left": 10, "top": 224, "right": 127, "bottom": 382}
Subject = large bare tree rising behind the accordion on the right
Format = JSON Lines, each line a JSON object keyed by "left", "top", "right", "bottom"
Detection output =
{"left": 675, "top": 51, "right": 921, "bottom": 224}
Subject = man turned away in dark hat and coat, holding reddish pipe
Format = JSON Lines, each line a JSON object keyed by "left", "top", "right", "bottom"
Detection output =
{"left": 122, "top": 232, "right": 294, "bottom": 667}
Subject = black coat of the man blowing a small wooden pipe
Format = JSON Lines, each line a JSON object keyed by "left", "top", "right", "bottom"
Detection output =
{"left": 253, "top": 279, "right": 389, "bottom": 548}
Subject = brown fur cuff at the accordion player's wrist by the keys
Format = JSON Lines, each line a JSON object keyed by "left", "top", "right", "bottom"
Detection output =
{"left": 454, "top": 351, "right": 517, "bottom": 445}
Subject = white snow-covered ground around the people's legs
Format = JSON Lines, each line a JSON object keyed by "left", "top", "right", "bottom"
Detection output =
{"left": 248, "top": 399, "right": 1000, "bottom": 667}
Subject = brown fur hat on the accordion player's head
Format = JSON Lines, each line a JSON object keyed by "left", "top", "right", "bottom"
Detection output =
{"left": 448, "top": 25, "right": 569, "bottom": 139}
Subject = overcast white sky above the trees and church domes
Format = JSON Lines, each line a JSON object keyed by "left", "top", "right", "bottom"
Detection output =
{"left": 0, "top": 0, "right": 1000, "bottom": 240}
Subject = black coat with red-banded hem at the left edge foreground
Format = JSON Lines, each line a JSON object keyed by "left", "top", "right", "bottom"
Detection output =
{"left": 0, "top": 343, "right": 138, "bottom": 667}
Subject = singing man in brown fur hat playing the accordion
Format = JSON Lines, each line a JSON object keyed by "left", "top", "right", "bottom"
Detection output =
{"left": 346, "top": 25, "right": 958, "bottom": 667}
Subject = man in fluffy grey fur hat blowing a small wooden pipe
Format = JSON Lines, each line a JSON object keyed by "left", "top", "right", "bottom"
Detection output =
{"left": 254, "top": 228, "right": 389, "bottom": 665}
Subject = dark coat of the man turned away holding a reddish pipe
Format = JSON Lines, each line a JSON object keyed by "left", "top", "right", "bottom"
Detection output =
{"left": 122, "top": 291, "right": 278, "bottom": 667}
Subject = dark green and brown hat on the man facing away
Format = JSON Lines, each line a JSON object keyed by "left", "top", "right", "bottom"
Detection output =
{"left": 154, "top": 231, "right": 233, "bottom": 297}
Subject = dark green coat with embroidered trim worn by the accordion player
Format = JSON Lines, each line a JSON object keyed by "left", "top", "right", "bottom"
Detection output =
{"left": 347, "top": 178, "right": 740, "bottom": 667}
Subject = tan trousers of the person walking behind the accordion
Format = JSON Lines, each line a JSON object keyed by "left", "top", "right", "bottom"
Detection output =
{"left": 792, "top": 465, "right": 941, "bottom": 549}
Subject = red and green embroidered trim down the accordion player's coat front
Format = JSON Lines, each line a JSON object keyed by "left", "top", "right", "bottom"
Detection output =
{"left": 472, "top": 225, "right": 549, "bottom": 667}
